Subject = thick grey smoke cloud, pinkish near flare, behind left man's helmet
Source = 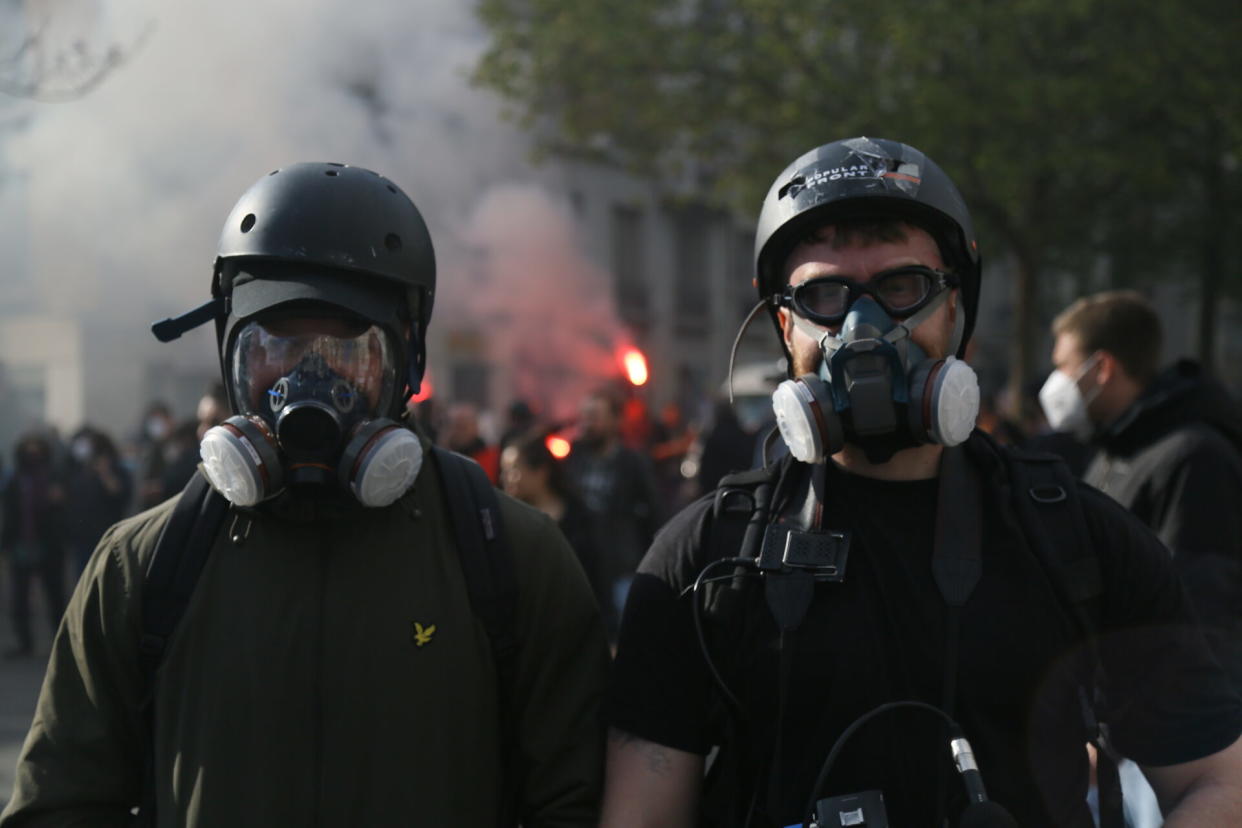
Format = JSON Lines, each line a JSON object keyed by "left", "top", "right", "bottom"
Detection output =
{"left": 0, "top": 0, "right": 615, "bottom": 428}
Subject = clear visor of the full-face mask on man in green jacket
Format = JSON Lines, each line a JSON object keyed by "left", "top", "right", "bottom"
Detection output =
{"left": 231, "top": 317, "right": 396, "bottom": 416}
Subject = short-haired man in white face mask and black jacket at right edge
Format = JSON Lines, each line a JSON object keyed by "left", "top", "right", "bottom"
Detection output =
{"left": 1040, "top": 290, "right": 1242, "bottom": 686}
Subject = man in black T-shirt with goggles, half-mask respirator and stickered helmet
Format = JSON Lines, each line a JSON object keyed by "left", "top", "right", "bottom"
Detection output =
{"left": 602, "top": 138, "right": 1242, "bottom": 828}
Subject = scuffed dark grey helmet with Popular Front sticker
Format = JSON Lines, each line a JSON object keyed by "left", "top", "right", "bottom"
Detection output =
{"left": 755, "top": 138, "right": 980, "bottom": 356}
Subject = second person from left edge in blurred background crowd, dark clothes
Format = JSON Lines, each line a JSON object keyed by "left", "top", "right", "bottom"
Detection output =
{"left": 65, "top": 426, "right": 134, "bottom": 575}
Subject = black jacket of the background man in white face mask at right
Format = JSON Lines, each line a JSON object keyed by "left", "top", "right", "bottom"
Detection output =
{"left": 1084, "top": 360, "right": 1242, "bottom": 686}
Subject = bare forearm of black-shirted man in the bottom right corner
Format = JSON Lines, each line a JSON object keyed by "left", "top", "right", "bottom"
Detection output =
{"left": 1143, "top": 739, "right": 1242, "bottom": 828}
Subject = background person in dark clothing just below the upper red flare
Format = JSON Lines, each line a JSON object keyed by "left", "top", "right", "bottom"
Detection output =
{"left": 566, "top": 390, "right": 661, "bottom": 636}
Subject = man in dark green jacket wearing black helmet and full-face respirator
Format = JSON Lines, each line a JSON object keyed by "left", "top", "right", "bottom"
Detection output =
{"left": 0, "top": 164, "right": 609, "bottom": 828}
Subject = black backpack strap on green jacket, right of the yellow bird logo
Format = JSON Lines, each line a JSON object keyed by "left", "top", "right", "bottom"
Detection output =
{"left": 432, "top": 446, "right": 523, "bottom": 828}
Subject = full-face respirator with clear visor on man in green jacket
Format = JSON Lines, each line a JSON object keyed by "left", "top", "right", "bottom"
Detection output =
{"left": 200, "top": 317, "right": 422, "bottom": 506}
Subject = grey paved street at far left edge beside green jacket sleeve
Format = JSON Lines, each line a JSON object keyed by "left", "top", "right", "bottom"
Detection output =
{"left": 0, "top": 565, "right": 60, "bottom": 808}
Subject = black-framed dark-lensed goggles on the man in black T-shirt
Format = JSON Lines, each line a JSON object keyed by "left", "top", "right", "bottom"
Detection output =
{"left": 776, "top": 264, "right": 959, "bottom": 325}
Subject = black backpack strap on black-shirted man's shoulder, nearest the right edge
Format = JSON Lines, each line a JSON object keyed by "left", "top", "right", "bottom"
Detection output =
{"left": 1006, "top": 451, "right": 1125, "bottom": 828}
